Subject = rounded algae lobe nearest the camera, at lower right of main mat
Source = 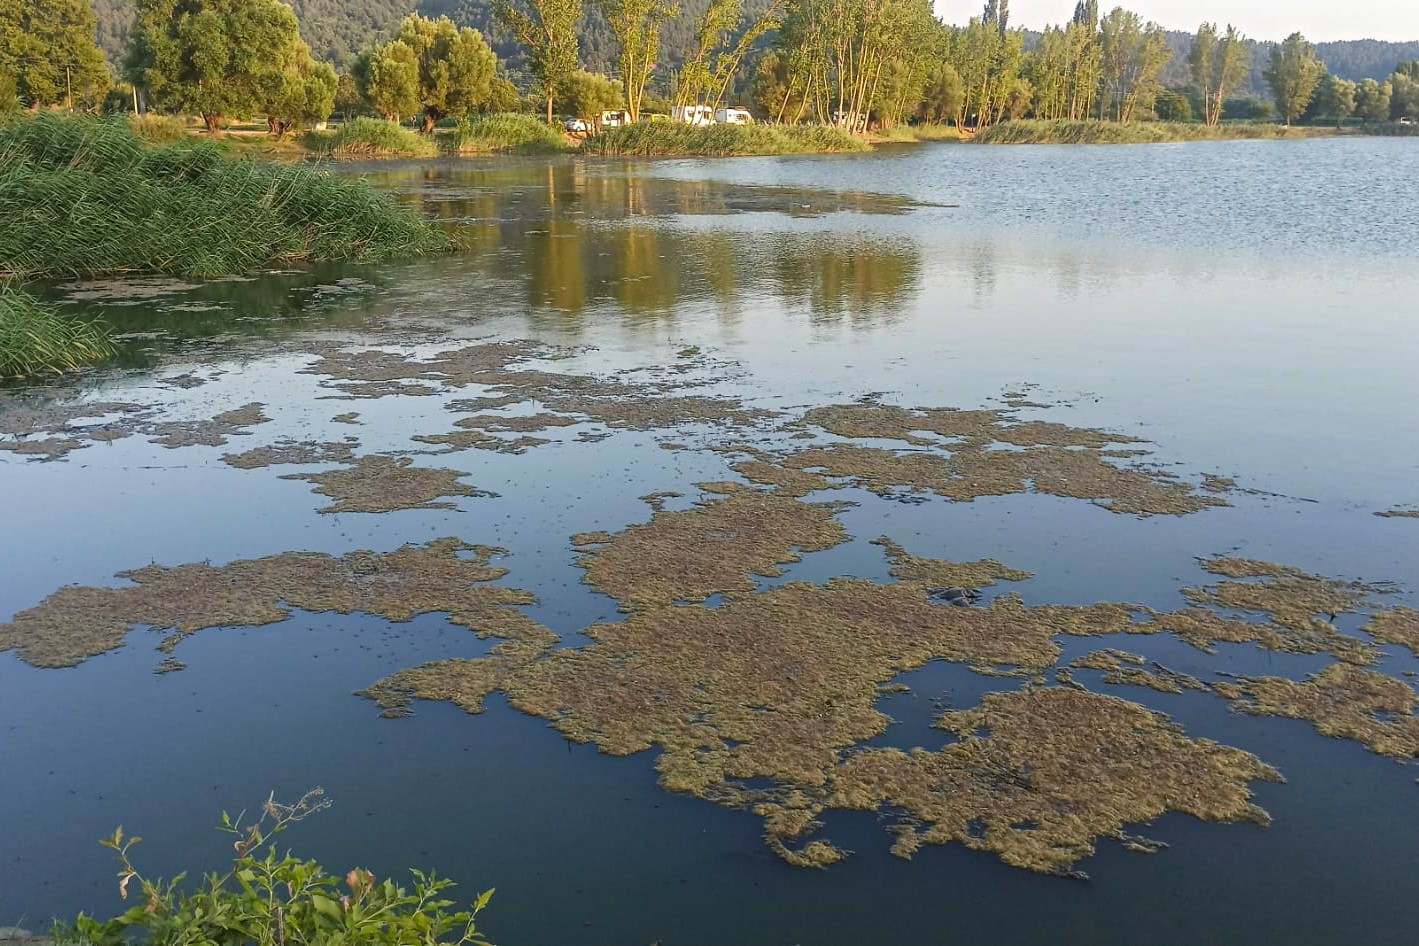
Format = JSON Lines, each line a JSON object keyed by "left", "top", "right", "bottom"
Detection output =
{"left": 829, "top": 686, "right": 1280, "bottom": 874}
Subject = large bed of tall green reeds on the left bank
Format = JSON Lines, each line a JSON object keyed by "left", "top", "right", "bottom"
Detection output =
{"left": 0, "top": 113, "right": 450, "bottom": 278}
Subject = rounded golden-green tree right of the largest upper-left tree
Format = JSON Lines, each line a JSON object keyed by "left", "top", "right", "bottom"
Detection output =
{"left": 358, "top": 14, "right": 502, "bottom": 132}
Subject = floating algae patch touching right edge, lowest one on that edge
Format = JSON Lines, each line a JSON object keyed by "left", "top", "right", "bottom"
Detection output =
{"left": 1218, "top": 664, "right": 1419, "bottom": 759}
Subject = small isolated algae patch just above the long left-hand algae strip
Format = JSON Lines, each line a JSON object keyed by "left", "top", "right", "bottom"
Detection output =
{"left": 282, "top": 455, "right": 494, "bottom": 512}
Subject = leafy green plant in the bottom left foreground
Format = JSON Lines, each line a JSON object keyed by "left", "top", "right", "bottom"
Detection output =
{"left": 54, "top": 789, "right": 492, "bottom": 946}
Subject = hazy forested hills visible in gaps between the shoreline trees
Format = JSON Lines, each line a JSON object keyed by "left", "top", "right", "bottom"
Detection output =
{"left": 94, "top": 0, "right": 1419, "bottom": 84}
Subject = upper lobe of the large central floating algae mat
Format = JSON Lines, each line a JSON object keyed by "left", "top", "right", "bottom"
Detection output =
{"left": 572, "top": 484, "right": 849, "bottom": 608}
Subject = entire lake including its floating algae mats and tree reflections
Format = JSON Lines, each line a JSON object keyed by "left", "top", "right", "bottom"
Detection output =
{"left": 0, "top": 138, "right": 1419, "bottom": 946}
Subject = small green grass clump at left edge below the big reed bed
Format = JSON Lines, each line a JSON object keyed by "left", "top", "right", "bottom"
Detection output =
{"left": 0, "top": 286, "right": 115, "bottom": 379}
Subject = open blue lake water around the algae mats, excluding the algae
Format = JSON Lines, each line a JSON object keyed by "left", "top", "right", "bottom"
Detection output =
{"left": 8, "top": 139, "right": 1419, "bottom": 946}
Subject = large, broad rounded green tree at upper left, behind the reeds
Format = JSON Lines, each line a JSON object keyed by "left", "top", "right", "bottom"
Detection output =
{"left": 125, "top": 0, "right": 323, "bottom": 133}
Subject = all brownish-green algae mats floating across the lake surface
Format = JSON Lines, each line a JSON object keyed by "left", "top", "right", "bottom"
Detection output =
{"left": 0, "top": 342, "right": 1419, "bottom": 875}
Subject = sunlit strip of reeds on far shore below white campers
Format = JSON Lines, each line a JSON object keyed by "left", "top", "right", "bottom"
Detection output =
{"left": 582, "top": 122, "right": 871, "bottom": 157}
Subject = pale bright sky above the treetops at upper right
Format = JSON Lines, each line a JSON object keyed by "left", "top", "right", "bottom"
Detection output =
{"left": 935, "top": 0, "right": 1419, "bottom": 41}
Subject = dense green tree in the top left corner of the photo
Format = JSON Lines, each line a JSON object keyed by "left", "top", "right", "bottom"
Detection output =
{"left": 0, "top": 0, "right": 112, "bottom": 109}
